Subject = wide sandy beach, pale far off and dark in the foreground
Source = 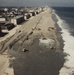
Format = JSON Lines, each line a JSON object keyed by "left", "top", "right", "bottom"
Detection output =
{"left": 0, "top": 8, "right": 64, "bottom": 75}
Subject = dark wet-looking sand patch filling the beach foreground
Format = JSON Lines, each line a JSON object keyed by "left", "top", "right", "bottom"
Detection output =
{"left": 9, "top": 39, "right": 64, "bottom": 75}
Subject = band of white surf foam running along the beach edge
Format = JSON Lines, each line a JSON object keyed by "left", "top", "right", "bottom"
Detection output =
{"left": 54, "top": 12, "right": 74, "bottom": 75}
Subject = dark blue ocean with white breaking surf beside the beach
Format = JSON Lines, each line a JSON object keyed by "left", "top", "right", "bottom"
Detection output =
{"left": 53, "top": 7, "right": 74, "bottom": 75}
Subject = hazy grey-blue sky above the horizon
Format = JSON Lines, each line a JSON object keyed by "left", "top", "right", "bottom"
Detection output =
{"left": 0, "top": 0, "right": 74, "bottom": 7}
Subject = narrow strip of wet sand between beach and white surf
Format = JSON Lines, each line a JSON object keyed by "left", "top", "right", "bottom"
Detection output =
{"left": 52, "top": 9, "right": 67, "bottom": 74}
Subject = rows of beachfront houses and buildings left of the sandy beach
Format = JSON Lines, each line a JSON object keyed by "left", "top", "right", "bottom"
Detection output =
{"left": 0, "top": 7, "right": 45, "bottom": 33}
